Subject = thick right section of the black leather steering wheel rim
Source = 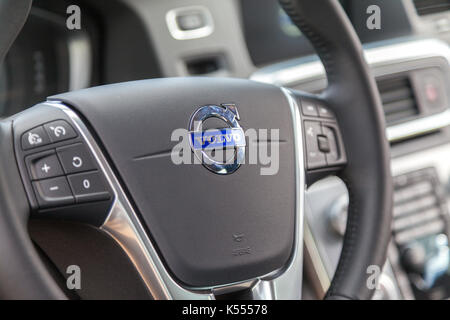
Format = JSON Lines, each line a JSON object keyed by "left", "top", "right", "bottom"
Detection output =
{"left": 280, "top": 0, "right": 393, "bottom": 299}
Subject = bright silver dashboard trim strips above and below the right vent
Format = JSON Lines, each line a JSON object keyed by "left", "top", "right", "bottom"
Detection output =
{"left": 250, "top": 39, "right": 450, "bottom": 142}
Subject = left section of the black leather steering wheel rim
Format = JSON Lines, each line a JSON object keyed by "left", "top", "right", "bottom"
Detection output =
{"left": 0, "top": 0, "right": 66, "bottom": 299}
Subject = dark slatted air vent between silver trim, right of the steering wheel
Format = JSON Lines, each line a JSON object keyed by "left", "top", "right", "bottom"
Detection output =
{"left": 378, "top": 76, "right": 419, "bottom": 124}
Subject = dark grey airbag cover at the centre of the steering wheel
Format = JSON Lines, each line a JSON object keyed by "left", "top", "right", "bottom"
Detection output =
{"left": 50, "top": 78, "right": 297, "bottom": 288}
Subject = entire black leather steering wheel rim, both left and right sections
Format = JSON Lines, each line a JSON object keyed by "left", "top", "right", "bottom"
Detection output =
{"left": 0, "top": 0, "right": 392, "bottom": 299}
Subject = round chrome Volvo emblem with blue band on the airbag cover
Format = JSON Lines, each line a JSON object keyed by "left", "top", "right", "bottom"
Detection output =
{"left": 189, "top": 104, "right": 245, "bottom": 174}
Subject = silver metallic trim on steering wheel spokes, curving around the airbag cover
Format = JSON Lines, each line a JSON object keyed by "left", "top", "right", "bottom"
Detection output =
{"left": 45, "top": 93, "right": 306, "bottom": 300}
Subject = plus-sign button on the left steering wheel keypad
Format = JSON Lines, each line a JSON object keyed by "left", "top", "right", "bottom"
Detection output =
{"left": 25, "top": 151, "right": 64, "bottom": 180}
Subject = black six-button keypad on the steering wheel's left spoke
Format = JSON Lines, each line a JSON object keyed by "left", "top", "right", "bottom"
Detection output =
{"left": 18, "top": 119, "right": 111, "bottom": 212}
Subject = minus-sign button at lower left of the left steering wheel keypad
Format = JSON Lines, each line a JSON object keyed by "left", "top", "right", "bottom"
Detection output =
{"left": 33, "top": 177, "right": 75, "bottom": 208}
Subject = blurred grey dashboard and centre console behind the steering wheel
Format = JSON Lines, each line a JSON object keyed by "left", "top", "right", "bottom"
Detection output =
{"left": 0, "top": 0, "right": 450, "bottom": 299}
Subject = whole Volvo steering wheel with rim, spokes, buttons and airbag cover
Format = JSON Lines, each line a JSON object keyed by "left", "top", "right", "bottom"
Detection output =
{"left": 0, "top": 0, "right": 392, "bottom": 299}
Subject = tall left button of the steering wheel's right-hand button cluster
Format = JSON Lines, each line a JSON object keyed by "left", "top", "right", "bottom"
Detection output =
{"left": 305, "top": 121, "right": 327, "bottom": 169}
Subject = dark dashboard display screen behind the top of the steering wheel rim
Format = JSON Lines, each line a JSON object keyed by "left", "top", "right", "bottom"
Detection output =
{"left": 240, "top": 0, "right": 412, "bottom": 66}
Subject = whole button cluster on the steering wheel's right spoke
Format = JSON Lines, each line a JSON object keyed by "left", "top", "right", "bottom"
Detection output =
{"left": 301, "top": 98, "right": 346, "bottom": 170}
